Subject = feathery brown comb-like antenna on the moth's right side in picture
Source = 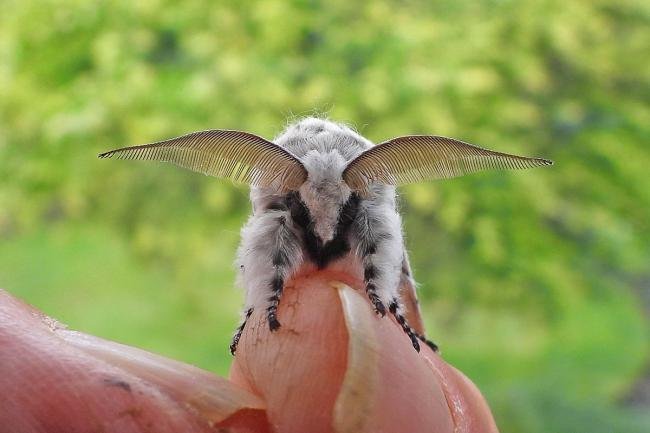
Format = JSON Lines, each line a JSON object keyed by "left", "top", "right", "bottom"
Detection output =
{"left": 342, "top": 135, "right": 553, "bottom": 191}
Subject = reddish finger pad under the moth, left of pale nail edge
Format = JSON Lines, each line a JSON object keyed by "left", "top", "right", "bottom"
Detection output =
{"left": 230, "top": 278, "right": 348, "bottom": 433}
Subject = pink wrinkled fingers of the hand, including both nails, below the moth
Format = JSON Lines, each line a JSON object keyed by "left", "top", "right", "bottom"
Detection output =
{"left": 0, "top": 272, "right": 497, "bottom": 433}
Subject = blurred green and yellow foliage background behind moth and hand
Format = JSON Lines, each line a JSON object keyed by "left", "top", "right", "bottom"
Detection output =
{"left": 0, "top": 0, "right": 650, "bottom": 432}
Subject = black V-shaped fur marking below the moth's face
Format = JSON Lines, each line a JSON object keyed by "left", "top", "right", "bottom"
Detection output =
{"left": 272, "top": 192, "right": 361, "bottom": 269}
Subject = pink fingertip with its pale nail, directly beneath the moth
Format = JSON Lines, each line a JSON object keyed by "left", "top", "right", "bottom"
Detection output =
{"left": 230, "top": 273, "right": 453, "bottom": 433}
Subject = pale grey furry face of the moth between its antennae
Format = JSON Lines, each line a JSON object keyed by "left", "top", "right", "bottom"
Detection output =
{"left": 299, "top": 150, "right": 352, "bottom": 242}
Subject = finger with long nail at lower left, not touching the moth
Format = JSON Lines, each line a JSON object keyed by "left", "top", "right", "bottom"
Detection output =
{"left": 0, "top": 291, "right": 265, "bottom": 433}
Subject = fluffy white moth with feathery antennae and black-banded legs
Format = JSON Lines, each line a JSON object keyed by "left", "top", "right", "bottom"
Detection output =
{"left": 99, "top": 117, "right": 552, "bottom": 355}
